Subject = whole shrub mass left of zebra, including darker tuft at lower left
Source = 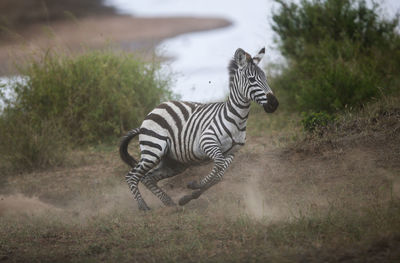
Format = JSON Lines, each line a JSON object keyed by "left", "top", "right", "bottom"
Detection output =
{"left": 0, "top": 51, "right": 171, "bottom": 173}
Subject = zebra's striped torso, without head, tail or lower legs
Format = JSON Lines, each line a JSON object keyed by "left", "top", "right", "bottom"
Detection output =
{"left": 139, "top": 101, "right": 248, "bottom": 164}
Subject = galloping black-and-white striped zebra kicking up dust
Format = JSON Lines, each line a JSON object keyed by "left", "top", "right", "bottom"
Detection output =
{"left": 119, "top": 48, "right": 279, "bottom": 210}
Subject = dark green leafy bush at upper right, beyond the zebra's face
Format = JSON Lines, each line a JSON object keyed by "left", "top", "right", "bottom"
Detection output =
{"left": 273, "top": 0, "right": 400, "bottom": 114}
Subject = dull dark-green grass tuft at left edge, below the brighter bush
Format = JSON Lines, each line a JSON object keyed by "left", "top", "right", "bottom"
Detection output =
{"left": 0, "top": 111, "right": 69, "bottom": 173}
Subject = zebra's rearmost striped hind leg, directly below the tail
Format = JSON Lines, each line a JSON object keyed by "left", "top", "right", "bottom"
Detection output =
{"left": 125, "top": 157, "right": 159, "bottom": 210}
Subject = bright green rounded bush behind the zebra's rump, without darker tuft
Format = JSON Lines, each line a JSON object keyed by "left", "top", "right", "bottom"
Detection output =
{"left": 13, "top": 51, "right": 171, "bottom": 145}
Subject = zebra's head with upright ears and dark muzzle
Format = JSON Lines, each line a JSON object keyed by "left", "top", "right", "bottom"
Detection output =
{"left": 229, "top": 48, "right": 279, "bottom": 113}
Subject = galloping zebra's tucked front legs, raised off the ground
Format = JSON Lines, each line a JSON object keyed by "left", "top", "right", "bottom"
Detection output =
{"left": 179, "top": 154, "right": 234, "bottom": 206}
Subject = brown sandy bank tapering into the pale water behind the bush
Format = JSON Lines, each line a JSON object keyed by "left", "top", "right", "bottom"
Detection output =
{"left": 0, "top": 15, "right": 231, "bottom": 75}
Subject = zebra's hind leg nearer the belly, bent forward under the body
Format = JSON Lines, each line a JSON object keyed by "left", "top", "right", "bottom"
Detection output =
{"left": 141, "top": 160, "right": 187, "bottom": 206}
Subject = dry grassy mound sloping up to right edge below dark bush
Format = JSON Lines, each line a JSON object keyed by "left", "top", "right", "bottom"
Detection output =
{"left": 297, "top": 92, "right": 400, "bottom": 154}
